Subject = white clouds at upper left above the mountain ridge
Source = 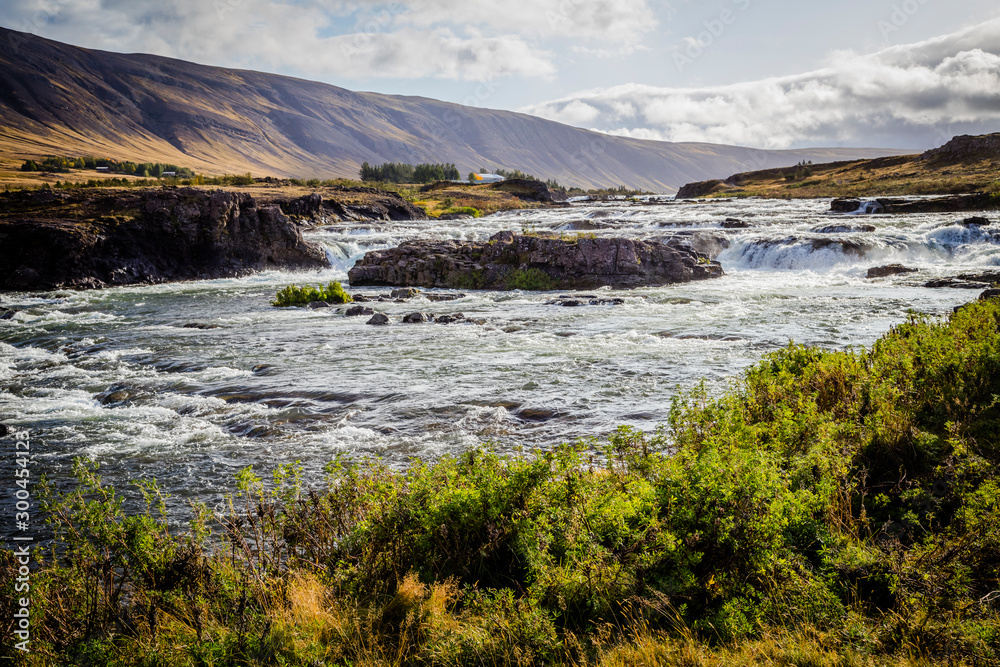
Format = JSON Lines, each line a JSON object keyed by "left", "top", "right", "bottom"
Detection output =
{"left": 0, "top": 0, "right": 656, "bottom": 81}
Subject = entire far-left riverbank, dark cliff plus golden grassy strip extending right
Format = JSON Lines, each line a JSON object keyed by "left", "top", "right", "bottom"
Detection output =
{"left": 0, "top": 180, "right": 558, "bottom": 290}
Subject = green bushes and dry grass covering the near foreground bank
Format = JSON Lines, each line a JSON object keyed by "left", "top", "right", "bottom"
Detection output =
{"left": 0, "top": 300, "right": 1000, "bottom": 666}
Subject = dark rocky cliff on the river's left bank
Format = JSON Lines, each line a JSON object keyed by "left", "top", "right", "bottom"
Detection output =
{"left": 0, "top": 188, "right": 329, "bottom": 290}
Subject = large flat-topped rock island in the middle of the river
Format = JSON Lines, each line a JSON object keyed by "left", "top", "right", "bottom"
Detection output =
{"left": 348, "top": 232, "right": 723, "bottom": 290}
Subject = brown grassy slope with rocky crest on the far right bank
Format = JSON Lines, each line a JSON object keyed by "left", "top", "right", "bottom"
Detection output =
{"left": 677, "top": 133, "right": 1000, "bottom": 198}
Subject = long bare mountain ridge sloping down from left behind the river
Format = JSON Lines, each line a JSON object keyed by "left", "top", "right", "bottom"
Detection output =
{"left": 0, "top": 28, "right": 903, "bottom": 192}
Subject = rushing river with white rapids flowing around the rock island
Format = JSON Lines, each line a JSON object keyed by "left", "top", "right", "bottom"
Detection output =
{"left": 0, "top": 200, "right": 1000, "bottom": 516}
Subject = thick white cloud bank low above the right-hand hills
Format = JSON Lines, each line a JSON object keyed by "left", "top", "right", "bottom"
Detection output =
{"left": 521, "top": 19, "right": 1000, "bottom": 148}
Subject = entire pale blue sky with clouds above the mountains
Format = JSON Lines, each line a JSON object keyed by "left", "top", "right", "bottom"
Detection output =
{"left": 0, "top": 0, "right": 1000, "bottom": 149}
